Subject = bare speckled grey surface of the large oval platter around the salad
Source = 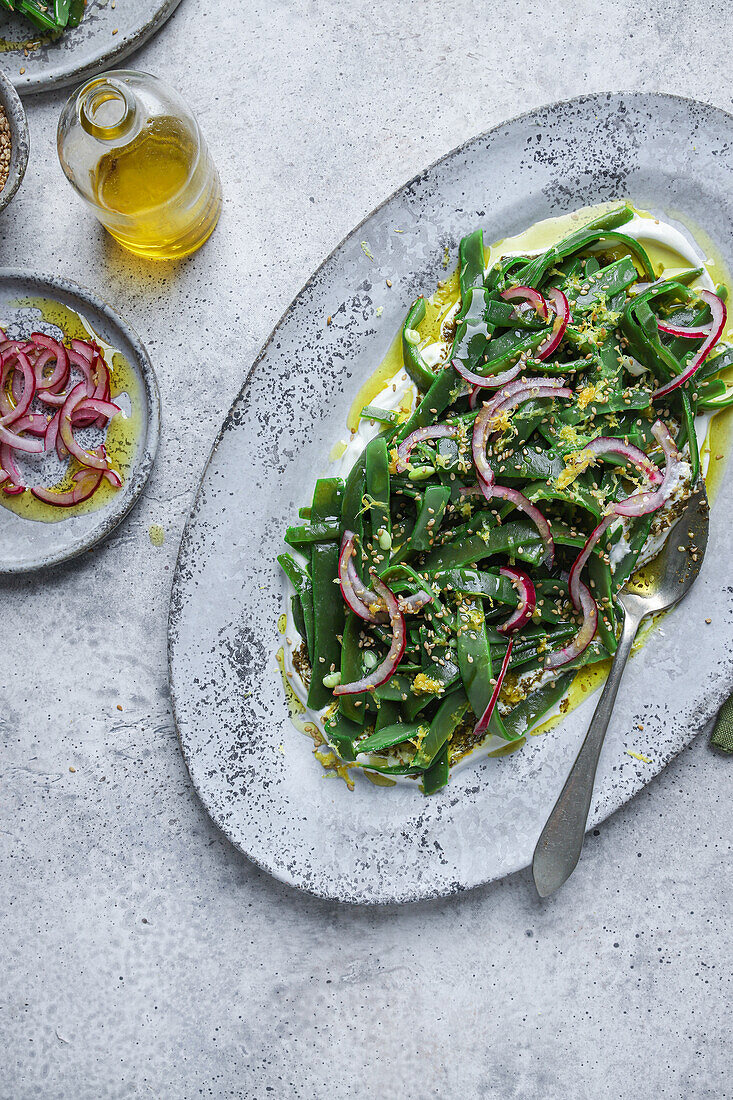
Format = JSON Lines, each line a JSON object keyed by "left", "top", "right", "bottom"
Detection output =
{"left": 169, "top": 94, "right": 733, "bottom": 902}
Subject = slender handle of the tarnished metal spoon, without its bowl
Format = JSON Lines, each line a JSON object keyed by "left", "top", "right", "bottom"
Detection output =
{"left": 532, "top": 608, "right": 643, "bottom": 898}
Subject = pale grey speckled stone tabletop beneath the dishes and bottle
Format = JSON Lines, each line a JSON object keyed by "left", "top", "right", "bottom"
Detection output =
{"left": 0, "top": 0, "right": 733, "bottom": 1100}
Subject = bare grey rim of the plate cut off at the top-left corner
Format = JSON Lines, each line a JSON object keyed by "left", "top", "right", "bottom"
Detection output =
{"left": 0, "top": 0, "right": 180, "bottom": 96}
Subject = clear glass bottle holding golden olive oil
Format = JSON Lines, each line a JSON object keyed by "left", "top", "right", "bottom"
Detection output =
{"left": 58, "top": 70, "right": 221, "bottom": 260}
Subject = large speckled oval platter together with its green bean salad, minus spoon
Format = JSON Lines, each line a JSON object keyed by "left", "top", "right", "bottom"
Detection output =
{"left": 171, "top": 95, "right": 733, "bottom": 902}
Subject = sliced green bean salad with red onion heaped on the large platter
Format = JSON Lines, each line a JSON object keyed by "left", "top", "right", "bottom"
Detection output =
{"left": 277, "top": 205, "right": 733, "bottom": 794}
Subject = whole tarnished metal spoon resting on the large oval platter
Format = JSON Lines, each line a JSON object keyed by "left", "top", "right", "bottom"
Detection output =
{"left": 532, "top": 484, "right": 709, "bottom": 898}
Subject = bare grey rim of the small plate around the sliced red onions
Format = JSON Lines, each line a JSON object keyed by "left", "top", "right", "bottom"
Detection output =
{"left": 0, "top": 267, "right": 161, "bottom": 575}
